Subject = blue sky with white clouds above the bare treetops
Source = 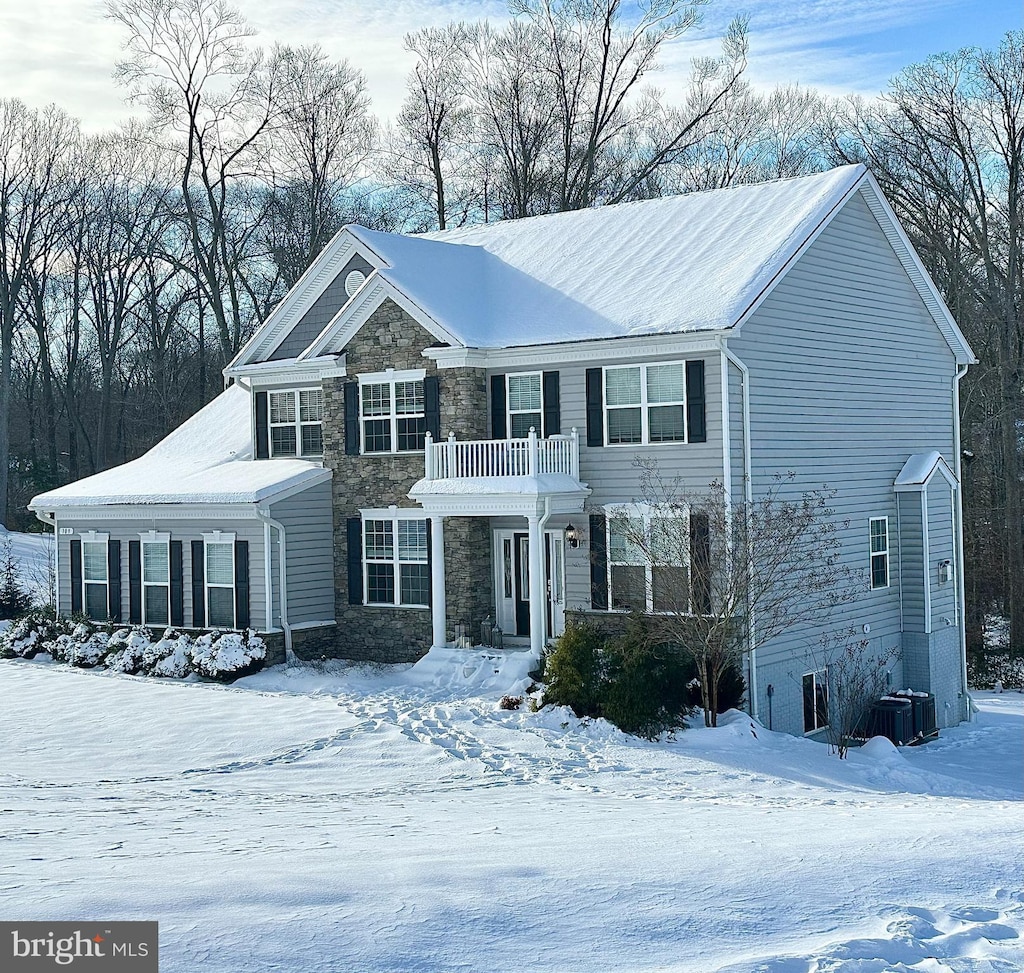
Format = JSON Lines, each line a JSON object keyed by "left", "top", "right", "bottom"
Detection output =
{"left": 0, "top": 0, "right": 1024, "bottom": 131}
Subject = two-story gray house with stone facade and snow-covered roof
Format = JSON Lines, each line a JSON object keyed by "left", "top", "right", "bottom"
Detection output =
{"left": 32, "top": 166, "right": 975, "bottom": 733}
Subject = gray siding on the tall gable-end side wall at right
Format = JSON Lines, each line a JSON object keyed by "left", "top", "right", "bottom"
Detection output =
{"left": 729, "top": 188, "right": 955, "bottom": 684}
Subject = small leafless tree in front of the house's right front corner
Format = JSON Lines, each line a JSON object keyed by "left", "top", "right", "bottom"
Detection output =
{"left": 608, "top": 458, "right": 857, "bottom": 726}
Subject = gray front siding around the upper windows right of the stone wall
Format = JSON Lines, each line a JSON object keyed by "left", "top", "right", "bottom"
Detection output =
{"left": 487, "top": 352, "right": 724, "bottom": 609}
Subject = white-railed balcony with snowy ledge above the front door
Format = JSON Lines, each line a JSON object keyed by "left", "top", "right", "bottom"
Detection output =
{"left": 409, "top": 429, "right": 590, "bottom": 516}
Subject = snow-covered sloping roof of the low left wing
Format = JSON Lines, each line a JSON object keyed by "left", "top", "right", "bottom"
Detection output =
{"left": 29, "top": 385, "right": 331, "bottom": 510}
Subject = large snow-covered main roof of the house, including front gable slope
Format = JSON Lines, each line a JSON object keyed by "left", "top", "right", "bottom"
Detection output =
{"left": 349, "top": 165, "right": 866, "bottom": 348}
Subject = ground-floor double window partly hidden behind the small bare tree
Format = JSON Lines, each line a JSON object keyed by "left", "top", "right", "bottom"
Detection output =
{"left": 607, "top": 511, "right": 690, "bottom": 612}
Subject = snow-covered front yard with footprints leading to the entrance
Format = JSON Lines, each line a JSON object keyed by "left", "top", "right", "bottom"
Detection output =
{"left": 0, "top": 654, "right": 1024, "bottom": 973}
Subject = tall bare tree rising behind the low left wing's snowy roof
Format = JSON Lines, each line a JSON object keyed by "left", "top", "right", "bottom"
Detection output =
{"left": 108, "top": 0, "right": 281, "bottom": 359}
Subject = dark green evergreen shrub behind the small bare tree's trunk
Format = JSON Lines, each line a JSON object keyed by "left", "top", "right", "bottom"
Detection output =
{"left": 602, "top": 615, "right": 691, "bottom": 739}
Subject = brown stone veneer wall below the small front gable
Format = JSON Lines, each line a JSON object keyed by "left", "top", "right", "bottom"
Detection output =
{"left": 324, "top": 300, "right": 495, "bottom": 663}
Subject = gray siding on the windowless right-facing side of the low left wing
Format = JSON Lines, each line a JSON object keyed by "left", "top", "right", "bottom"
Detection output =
{"left": 270, "top": 480, "right": 334, "bottom": 626}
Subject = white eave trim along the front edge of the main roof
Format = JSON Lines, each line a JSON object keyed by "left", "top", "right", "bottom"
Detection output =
{"left": 421, "top": 329, "right": 725, "bottom": 371}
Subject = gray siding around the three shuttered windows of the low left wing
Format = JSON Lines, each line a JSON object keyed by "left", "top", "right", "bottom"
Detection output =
{"left": 57, "top": 511, "right": 266, "bottom": 629}
